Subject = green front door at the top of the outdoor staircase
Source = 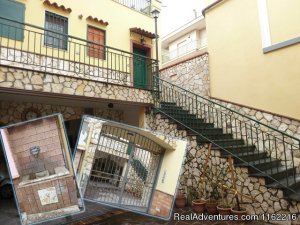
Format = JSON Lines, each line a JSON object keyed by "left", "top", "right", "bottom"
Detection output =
{"left": 133, "top": 48, "right": 147, "bottom": 88}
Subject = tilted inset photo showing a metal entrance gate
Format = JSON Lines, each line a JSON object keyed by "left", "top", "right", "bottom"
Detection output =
{"left": 74, "top": 116, "right": 187, "bottom": 220}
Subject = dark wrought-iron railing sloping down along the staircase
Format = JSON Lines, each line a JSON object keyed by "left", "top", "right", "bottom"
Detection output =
{"left": 155, "top": 78, "right": 300, "bottom": 194}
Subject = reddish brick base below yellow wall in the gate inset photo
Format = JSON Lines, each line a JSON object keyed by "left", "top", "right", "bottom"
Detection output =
{"left": 149, "top": 191, "right": 174, "bottom": 218}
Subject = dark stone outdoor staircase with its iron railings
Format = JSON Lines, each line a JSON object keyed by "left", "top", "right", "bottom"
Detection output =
{"left": 155, "top": 78, "right": 300, "bottom": 201}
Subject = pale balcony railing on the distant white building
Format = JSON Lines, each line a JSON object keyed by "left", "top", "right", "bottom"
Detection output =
{"left": 162, "top": 40, "right": 207, "bottom": 63}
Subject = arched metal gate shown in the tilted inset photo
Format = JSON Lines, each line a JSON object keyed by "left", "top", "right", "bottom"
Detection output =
{"left": 85, "top": 125, "right": 163, "bottom": 212}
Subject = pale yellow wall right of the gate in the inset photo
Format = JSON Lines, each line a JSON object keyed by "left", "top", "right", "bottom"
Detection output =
{"left": 156, "top": 140, "right": 187, "bottom": 195}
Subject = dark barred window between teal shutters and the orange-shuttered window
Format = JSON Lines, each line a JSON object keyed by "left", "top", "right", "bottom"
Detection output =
{"left": 44, "top": 10, "right": 69, "bottom": 51}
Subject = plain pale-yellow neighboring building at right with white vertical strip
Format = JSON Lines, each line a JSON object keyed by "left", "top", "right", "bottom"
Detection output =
{"left": 204, "top": 0, "right": 300, "bottom": 119}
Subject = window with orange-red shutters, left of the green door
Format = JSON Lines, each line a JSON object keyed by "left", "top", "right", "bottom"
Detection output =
{"left": 87, "top": 26, "right": 105, "bottom": 59}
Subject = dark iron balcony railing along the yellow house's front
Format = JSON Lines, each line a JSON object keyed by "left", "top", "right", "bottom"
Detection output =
{"left": 0, "top": 17, "right": 156, "bottom": 90}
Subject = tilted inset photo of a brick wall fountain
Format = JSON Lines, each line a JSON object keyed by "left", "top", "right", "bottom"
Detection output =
{"left": 0, "top": 114, "right": 84, "bottom": 225}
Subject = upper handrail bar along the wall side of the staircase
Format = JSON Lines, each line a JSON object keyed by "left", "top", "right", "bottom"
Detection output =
{"left": 156, "top": 77, "right": 300, "bottom": 142}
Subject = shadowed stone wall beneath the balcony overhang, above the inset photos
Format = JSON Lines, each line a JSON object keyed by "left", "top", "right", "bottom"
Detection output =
{"left": 0, "top": 101, "right": 124, "bottom": 125}
